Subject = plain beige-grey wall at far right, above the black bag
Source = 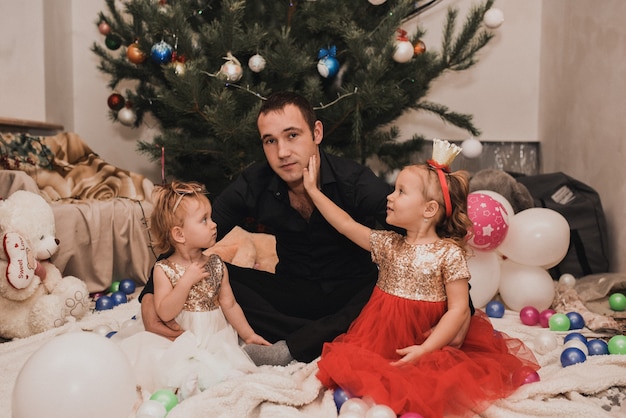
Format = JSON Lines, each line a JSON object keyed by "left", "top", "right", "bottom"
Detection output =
{"left": 539, "top": 0, "right": 626, "bottom": 271}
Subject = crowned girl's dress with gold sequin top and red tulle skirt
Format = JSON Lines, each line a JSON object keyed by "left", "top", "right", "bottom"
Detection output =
{"left": 317, "top": 231, "right": 539, "bottom": 417}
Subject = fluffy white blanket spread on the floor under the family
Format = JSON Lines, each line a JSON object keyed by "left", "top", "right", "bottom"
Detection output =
{"left": 0, "top": 300, "right": 626, "bottom": 418}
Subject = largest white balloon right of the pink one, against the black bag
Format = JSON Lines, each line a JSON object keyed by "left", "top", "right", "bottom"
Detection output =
{"left": 498, "top": 208, "right": 569, "bottom": 268}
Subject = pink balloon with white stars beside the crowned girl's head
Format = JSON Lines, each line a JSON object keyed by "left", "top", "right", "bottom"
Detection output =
{"left": 467, "top": 193, "right": 509, "bottom": 251}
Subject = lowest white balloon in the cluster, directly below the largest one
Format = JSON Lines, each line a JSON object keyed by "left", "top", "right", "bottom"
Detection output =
{"left": 499, "top": 260, "right": 555, "bottom": 312}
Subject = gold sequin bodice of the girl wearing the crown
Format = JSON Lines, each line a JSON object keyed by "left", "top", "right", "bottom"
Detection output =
{"left": 370, "top": 230, "right": 470, "bottom": 302}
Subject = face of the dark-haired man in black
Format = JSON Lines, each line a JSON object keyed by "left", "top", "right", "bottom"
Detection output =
{"left": 257, "top": 105, "right": 323, "bottom": 185}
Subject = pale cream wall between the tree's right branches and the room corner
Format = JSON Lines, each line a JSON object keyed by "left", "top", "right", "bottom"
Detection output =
{"left": 399, "top": 0, "right": 542, "bottom": 141}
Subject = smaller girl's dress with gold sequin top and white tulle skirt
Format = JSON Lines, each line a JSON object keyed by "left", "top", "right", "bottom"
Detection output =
{"left": 120, "top": 255, "right": 256, "bottom": 399}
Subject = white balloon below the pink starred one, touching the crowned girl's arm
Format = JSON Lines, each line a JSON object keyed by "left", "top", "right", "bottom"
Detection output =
{"left": 467, "top": 250, "right": 500, "bottom": 308}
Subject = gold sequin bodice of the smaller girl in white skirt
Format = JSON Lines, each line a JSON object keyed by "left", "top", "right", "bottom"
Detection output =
{"left": 156, "top": 254, "right": 225, "bottom": 312}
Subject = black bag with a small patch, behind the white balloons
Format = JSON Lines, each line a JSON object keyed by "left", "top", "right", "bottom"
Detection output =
{"left": 517, "top": 173, "right": 609, "bottom": 280}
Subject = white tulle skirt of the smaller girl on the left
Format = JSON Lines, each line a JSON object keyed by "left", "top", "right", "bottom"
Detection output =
{"left": 116, "top": 308, "right": 256, "bottom": 399}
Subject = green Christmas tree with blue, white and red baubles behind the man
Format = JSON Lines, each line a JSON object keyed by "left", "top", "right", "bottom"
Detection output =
{"left": 92, "top": 0, "right": 493, "bottom": 192}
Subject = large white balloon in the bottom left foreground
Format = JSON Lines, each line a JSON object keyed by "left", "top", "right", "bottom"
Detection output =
{"left": 12, "top": 331, "right": 137, "bottom": 418}
